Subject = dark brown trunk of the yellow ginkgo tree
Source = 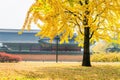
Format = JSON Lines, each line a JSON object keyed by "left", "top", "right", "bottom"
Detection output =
{"left": 82, "top": 27, "right": 91, "bottom": 67}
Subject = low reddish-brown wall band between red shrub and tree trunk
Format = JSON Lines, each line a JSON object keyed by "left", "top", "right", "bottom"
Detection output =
{"left": 16, "top": 54, "right": 82, "bottom": 61}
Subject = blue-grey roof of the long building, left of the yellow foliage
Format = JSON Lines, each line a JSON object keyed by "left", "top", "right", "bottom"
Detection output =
{"left": 0, "top": 29, "right": 39, "bottom": 43}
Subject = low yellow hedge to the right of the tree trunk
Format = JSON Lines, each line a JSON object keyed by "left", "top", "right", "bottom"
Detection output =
{"left": 91, "top": 53, "right": 120, "bottom": 62}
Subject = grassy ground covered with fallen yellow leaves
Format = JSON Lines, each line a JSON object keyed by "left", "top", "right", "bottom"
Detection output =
{"left": 0, "top": 62, "right": 120, "bottom": 80}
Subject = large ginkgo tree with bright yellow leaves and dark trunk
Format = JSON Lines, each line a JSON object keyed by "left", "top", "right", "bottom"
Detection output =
{"left": 19, "top": 0, "right": 120, "bottom": 66}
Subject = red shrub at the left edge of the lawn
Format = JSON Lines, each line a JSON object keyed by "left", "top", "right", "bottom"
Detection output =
{"left": 0, "top": 52, "right": 22, "bottom": 62}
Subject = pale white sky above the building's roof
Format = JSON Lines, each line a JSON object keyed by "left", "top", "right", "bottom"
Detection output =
{"left": 0, "top": 0, "right": 39, "bottom": 29}
